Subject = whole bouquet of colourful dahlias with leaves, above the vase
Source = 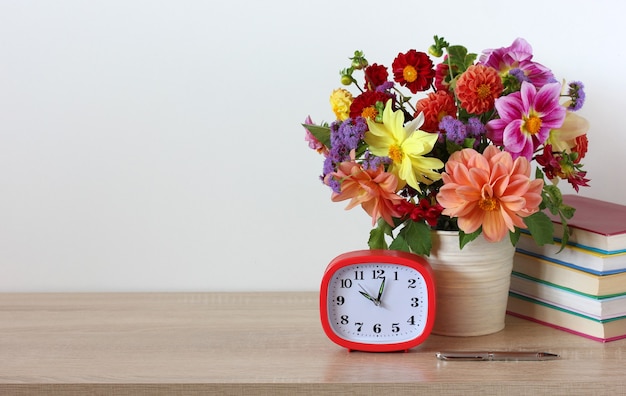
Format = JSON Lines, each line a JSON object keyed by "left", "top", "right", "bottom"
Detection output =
{"left": 303, "top": 36, "right": 589, "bottom": 255}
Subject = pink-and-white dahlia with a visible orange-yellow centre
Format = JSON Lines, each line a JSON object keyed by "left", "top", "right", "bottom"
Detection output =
{"left": 487, "top": 82, "right": 565, "bottom": 161}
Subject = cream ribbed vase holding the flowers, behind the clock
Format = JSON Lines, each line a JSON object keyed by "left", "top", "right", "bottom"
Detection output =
{"left": 426, "top": 231, "right": 515, "bottom": 336}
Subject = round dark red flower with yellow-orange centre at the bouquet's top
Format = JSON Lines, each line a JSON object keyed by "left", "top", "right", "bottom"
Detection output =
{"left": 391, "top": 50, "right": 435, "bottom": 93}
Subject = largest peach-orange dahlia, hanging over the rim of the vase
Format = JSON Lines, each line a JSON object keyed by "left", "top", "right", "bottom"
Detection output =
{"left": 437, "top": 146, "right": 543, "bottom": 242}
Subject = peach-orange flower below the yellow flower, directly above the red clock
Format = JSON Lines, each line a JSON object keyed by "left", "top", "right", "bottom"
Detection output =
{"left": 331, "top": 161, "right": 404, "bottom": 226}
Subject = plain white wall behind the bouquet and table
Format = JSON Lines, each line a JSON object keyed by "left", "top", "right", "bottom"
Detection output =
{"left": 0, "top": 0, "right": 626, "bottom": 291}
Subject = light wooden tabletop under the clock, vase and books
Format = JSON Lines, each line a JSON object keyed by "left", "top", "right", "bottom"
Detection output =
{"left": 0, "top": 293, "right": 626, "bottom": 396}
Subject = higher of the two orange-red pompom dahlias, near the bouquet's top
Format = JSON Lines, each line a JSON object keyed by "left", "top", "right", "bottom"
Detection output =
{"left": 454, "top": 65, "right": 504, "bottom": 114}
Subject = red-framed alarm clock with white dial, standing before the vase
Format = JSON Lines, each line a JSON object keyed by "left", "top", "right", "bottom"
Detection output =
{"left": 321, "top": 249, "right": 434, "bottom": 351}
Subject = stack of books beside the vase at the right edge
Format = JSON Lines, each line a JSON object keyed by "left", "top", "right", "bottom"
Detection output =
{"left": 507, "top": 195, "right": 626, "bottom": 342}
